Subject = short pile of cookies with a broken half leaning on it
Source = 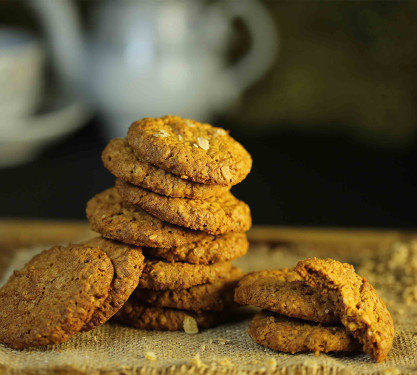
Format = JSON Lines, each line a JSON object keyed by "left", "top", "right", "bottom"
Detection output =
{"left": 235, "top": 258, "right": 394, "bottom": 362}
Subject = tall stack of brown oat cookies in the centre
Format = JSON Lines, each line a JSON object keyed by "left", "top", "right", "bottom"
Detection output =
{"left": 87, "top": 116, "right": 252, "bottom": 332}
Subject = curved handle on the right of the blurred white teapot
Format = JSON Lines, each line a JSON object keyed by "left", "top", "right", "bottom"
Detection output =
{"left": 216, "top": 0, "right": 279, "bottom": 93}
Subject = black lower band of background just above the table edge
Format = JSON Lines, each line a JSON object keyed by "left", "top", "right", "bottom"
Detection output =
{"left": 0, "top": 119, "right": 417, "bottom": 228}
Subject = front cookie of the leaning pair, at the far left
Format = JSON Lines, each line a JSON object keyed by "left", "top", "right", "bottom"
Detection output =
{"left": 0, "top": 245, "right": 114, "bottom": 349}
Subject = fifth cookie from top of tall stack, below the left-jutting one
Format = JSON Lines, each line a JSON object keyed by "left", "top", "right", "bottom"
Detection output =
{"left": 142, "top": 233, "right": 249, "bottom": 264}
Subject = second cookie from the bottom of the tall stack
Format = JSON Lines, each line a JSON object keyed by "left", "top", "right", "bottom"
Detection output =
{"left": 133, "top": 267, "right": 243, "bottom": 312}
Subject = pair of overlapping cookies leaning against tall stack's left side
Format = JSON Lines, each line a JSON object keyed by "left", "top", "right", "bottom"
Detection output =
{"left": 0, "top": 238, "right": 144, "bottom": 349}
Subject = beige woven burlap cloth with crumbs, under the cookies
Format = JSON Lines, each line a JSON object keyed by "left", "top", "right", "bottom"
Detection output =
{"left": 0, "top": 236, "right": 417, "bottom": 374}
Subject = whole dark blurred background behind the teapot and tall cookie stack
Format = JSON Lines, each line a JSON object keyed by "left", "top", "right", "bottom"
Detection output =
{"left": 0, "top": 1, "right": 417, "bottom": 228}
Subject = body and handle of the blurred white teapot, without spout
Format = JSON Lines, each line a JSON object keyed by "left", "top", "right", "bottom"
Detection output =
{"left": 86, "top": 0, "right": 278, "bottom": 137}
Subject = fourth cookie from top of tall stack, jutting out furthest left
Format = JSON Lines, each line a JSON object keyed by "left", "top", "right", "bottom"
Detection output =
{"left": 86, "top": 188, "right": 208, "bottom": 247}
